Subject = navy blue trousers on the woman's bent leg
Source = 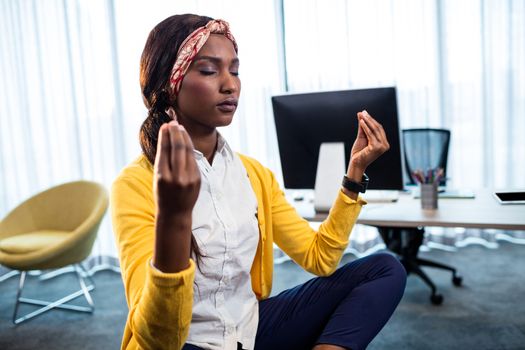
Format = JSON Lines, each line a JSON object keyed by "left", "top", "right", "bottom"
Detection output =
{"left": 183, "top": 253, "right": 406, "bottom": 350}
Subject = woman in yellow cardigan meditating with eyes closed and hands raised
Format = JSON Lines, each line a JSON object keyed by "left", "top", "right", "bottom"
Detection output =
{"left": 112, "top": 15, "right": 406, "bottom": 349}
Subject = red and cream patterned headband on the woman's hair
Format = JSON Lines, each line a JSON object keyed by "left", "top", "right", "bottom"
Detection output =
{"left": 170, "top": 19, "right": 237, "bottom": 96}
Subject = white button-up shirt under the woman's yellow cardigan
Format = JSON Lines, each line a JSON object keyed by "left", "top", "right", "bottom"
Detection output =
{"left": 186, "top": 135, "right": 259, "bottom": 350}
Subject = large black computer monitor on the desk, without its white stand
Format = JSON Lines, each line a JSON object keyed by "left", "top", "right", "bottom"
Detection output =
{"left": 272, "top": 87, "right": 403, "bottom": 190}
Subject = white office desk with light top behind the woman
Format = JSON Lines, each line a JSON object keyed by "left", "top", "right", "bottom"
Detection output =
{"left": 295, "top": 189, "right": 525, "bottom": 230}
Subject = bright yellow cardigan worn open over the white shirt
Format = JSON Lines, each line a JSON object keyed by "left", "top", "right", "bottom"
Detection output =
{"left": 111, "top": 155, "right": 366, "bottom": 349}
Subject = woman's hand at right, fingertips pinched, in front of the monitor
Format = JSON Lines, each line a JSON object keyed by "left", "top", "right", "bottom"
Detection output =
{"left": 348, "top": 111, "right": 390, "bottom": 175}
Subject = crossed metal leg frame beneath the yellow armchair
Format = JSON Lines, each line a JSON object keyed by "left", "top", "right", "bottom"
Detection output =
{"left": 13, "top": 265, "right": 95, "bottom": 324}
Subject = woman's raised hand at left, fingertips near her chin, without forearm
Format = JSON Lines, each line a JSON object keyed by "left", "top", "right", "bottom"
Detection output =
{"left": 153, "top": 120, "right": 201, "bottom": 217}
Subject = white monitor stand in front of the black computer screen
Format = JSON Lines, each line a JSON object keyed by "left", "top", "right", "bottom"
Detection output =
{"left": 314, "top": 142, "right": 346, "bottom": 212}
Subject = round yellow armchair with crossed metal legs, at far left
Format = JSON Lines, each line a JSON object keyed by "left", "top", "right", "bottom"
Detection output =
{"left": 0, "top": 181, "right": 108, "bottom": 324}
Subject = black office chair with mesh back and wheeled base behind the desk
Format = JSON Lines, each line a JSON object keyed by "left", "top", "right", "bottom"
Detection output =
{"left": 378, "top": 129, "right": 462, "bottom": 305}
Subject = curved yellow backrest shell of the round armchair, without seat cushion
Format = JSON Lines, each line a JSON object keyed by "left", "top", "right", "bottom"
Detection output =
{"left": 0, "top": 181, "right": 108, "bottom": 270}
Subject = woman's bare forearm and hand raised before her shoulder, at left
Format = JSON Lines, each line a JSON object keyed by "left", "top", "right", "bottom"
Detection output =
{"left": 153, "top": 118, "right": 201, "bottom": 272}
